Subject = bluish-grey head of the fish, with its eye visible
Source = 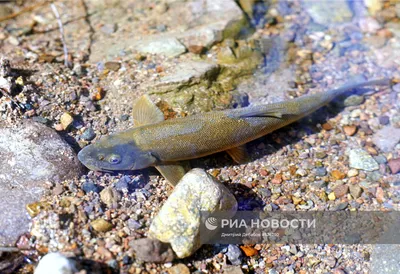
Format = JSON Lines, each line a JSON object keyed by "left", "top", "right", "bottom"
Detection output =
{"left": 78, "top": 135, "right": 156, "bottom": 171}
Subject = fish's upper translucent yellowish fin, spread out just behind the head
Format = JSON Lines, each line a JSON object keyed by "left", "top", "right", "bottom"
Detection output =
{"left": 132, "top": 94, "right": 164, "bottom": 126}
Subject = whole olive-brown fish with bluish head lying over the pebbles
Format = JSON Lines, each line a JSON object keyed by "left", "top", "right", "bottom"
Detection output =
{"left": 78, "top": 79, "right": 391, "bottom": 186}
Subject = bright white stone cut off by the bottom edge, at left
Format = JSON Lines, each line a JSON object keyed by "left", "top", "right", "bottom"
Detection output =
{"left": 34, "top": 252, "right": 78, "bottom": 274}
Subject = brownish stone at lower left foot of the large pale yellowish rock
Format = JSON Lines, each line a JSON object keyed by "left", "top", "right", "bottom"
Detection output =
{"left": 129, "top": 238, "right": 175, "bottom": 263}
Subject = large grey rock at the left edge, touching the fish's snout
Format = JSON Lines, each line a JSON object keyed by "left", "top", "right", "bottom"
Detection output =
{"left": 0, "top": 120, "right": 82, "bottom": 245}
